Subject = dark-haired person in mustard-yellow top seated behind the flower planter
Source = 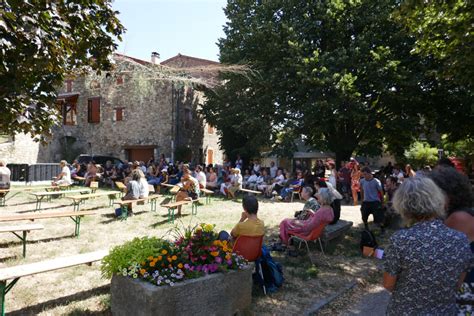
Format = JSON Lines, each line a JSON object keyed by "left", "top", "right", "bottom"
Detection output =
{"left": 219, "top": 195, "right": 265, "bottom": 240}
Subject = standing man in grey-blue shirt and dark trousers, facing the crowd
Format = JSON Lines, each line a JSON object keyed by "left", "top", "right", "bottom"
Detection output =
{"left": 360, "top": 167, "right": 385, "bottom": 235}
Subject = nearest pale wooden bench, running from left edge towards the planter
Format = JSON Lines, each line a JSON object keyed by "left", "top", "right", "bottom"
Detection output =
{"left": 0, "top": 250, "right": 108, "bottom": 316}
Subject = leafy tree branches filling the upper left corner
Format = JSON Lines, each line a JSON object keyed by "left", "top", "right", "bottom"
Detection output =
{"left": 0, "top": 0, "right": 124, "bottom": 137}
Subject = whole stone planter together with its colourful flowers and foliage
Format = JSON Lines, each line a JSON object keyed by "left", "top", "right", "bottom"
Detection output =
{"left": 101, "top": 224, "right": 252, "bottom": 315}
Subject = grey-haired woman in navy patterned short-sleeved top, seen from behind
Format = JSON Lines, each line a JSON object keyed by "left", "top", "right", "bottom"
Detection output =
{"left": 383, "top": 177, "right": 472, "bottom": 316}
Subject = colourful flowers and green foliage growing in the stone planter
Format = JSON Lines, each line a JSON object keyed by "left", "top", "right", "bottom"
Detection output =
{"left": 102, "top": 224, "right": 247, "bottom": 286}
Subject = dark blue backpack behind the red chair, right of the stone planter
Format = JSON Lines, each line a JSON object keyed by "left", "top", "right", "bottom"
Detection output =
{"left": 253, "top": 246, "right": 285, "bottom": 293}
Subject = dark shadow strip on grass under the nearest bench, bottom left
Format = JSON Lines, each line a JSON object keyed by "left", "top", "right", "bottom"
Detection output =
{"left": 7, "top": 285, "right": 111, "bottom": 315}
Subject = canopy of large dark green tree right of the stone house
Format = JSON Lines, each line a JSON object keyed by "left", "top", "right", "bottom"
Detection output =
{"left": 203, "top": 0, "right": 470, "bottom": 160}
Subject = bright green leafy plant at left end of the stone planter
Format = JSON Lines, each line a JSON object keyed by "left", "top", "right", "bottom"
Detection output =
{"left": 100, "top": 237, "right": 168, "bottom": 279}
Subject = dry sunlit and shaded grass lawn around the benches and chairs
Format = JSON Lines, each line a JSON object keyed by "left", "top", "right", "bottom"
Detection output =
{"left": 0, "top": 187, "right": 386, "bottom": 315}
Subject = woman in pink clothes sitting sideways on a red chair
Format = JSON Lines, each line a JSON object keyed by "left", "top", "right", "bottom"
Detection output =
{"left": 280, "top": 188, "right": 334, "bottom": 245}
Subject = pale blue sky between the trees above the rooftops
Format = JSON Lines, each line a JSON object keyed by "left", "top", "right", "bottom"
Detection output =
{"left": 112, "top": 0, "right": 226, "bottom": 61}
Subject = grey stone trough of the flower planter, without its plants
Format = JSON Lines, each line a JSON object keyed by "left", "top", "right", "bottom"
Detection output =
{"left": 111, "top": 265, "right": 253, "bottom": 316}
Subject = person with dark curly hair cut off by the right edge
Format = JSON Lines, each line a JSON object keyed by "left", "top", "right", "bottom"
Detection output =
{"left": 429, "top": 166, "right": 474, "bottom": 315}
